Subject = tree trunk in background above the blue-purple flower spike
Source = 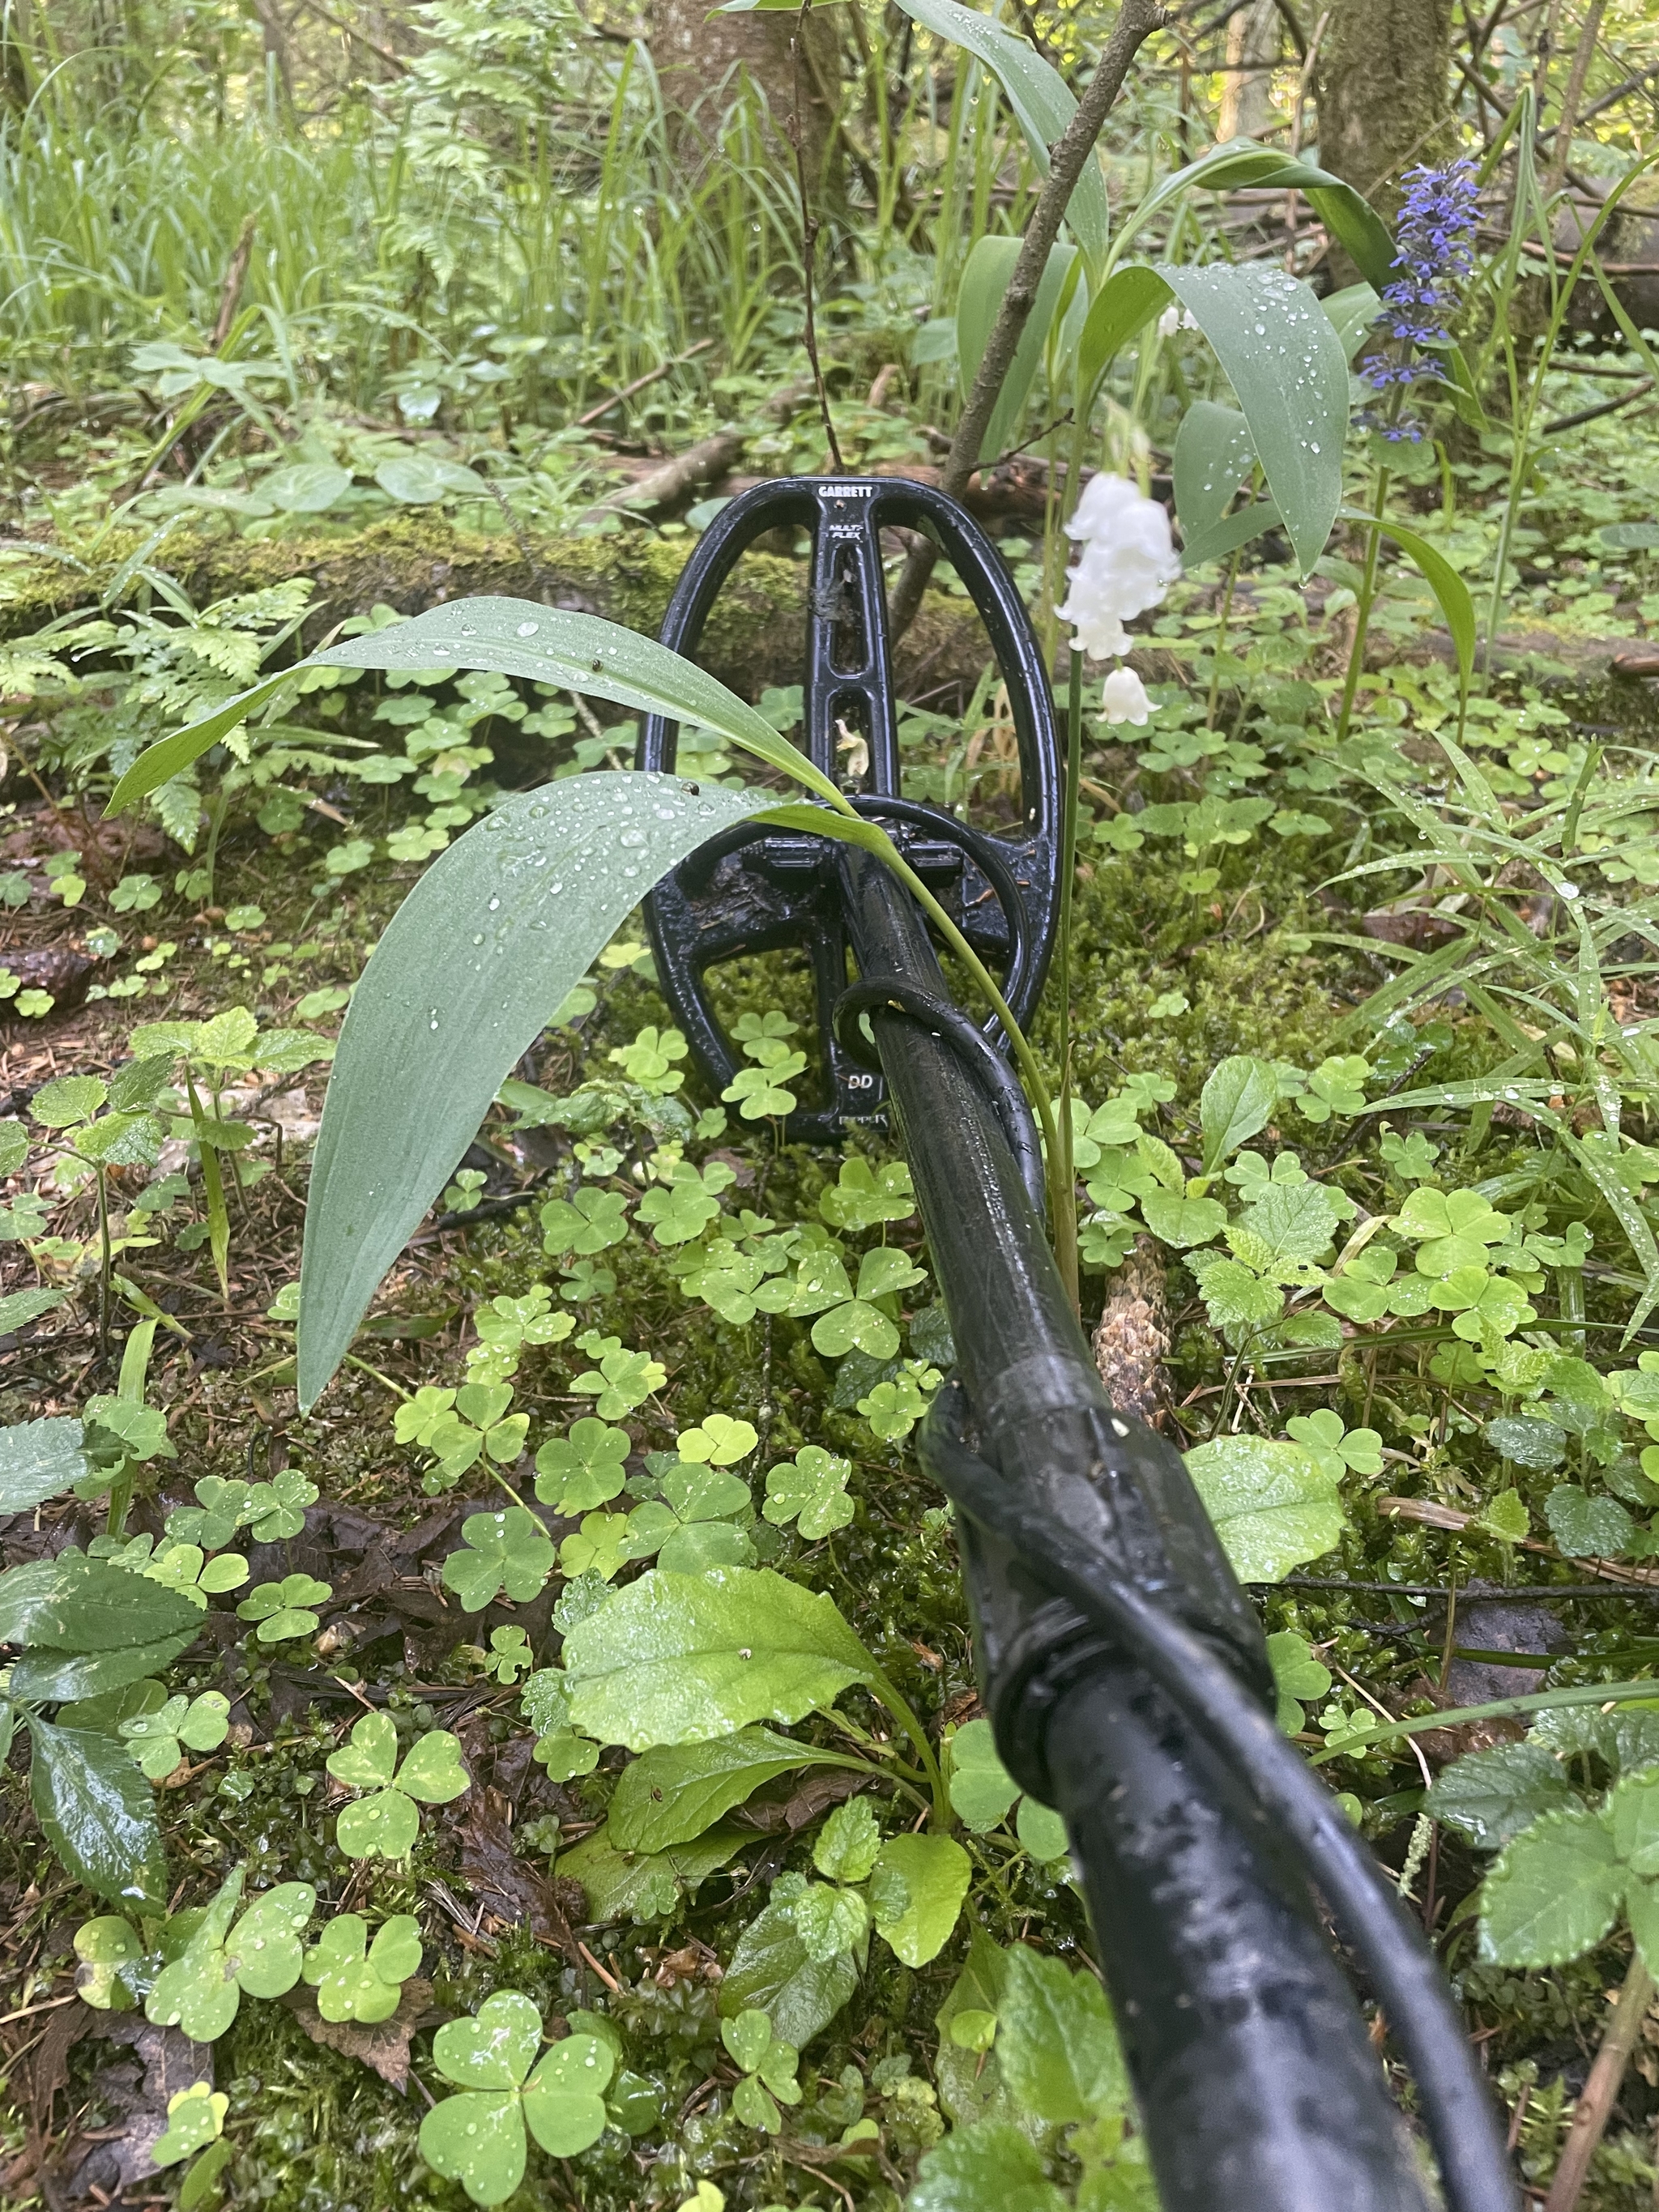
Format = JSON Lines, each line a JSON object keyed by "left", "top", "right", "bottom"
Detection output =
{"left": 1316, "top": 0, "right": 1458, "bottom": 283}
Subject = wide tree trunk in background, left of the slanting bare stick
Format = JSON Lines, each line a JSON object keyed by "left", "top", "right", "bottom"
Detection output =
{"left": 650, "top": 0, "right": 845, "bottom": 215}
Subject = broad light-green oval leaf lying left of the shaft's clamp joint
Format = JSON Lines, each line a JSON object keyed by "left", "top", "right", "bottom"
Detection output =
{"left": 564, "top": 1568, "right": 878, "bottom": 1751}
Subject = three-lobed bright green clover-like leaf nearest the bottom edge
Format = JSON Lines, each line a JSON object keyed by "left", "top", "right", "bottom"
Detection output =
{"left": 420, "top": 1988, "right": 615, "bottom": 2206}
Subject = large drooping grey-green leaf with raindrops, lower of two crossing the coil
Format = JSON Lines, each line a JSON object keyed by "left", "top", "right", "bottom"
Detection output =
{"left": 299, "top": 778, "right": 781, "bottom": 1407}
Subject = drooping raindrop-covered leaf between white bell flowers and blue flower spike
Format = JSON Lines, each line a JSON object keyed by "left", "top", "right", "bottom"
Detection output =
{"left": 1159, "top": 261, "right": 1347, "bottom": 575}
